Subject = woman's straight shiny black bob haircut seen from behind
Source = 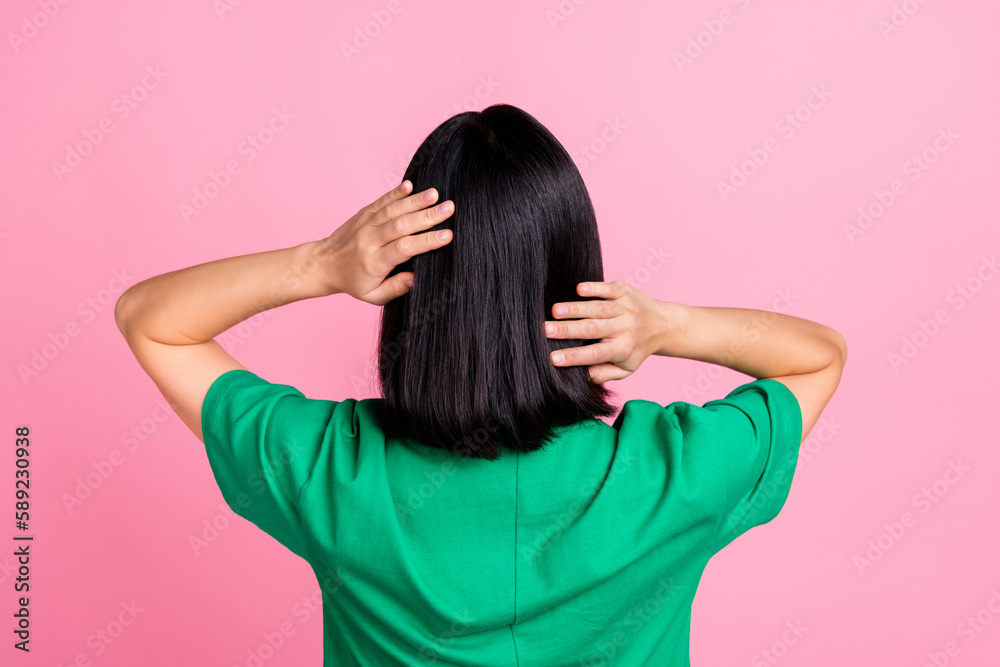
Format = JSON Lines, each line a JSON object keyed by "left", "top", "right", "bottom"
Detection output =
{"left": 378, "top": 104, "right": 615, "bottom": 460}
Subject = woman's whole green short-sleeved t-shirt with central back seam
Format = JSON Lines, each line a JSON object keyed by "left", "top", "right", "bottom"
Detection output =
{"left": 202, "top": 370, "right": 802, "bottom": 667}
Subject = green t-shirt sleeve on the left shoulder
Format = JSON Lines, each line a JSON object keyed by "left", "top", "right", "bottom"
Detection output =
{"left": 201, "top": 369, "right": 336, "bottom": 558}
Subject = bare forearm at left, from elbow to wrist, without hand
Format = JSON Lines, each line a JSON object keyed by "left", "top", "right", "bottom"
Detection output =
{"left": 115, "top": 242, "right": 335, "bottom": 345}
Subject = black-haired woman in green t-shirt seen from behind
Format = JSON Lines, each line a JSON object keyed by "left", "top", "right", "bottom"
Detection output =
{"left": 115, "top": 105, "right": 847, "bottom": 666}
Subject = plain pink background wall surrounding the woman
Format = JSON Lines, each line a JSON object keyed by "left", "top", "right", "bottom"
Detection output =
{"left": 0, "top": 0, "right": 1000, "bottom": 666}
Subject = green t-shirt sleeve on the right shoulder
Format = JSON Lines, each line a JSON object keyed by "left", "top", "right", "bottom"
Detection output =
{"left": 702, "top": 378, "right": 802, "bottom": 551}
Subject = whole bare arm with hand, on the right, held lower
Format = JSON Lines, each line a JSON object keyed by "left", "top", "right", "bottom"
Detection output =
{"left": 546, "top": 281, "right": 847, "bottom": 439}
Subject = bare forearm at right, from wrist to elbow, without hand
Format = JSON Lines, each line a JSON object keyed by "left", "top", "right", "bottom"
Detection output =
{"left": 655, "top": 302, "right": 846, "bottom": 378}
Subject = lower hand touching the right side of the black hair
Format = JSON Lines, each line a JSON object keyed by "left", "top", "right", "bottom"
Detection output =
{"left": 545, "top": 281, "right": 679, "bottom": 384}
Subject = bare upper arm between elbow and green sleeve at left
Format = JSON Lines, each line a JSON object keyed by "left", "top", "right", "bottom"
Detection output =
{"left": 115, "top": 309, "right": 245, "bottom": 442}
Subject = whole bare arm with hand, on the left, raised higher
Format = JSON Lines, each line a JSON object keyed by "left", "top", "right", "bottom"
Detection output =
{"left": 115, "top": 181, "right": 454, "bottom": 446}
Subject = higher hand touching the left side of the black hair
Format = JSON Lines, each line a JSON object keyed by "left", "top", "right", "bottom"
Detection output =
{"left": 320, "top": 181, "right": 455, "bottom": 306}
